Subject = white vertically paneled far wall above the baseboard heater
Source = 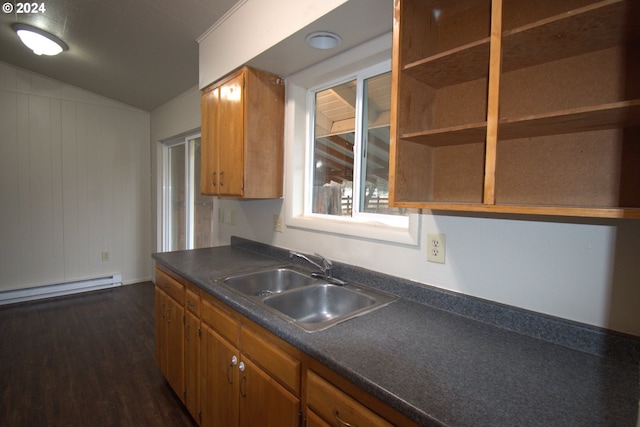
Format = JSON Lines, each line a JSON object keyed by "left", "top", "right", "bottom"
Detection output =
{"left": 0, "top": 62, "right": 151, "bottom": 291}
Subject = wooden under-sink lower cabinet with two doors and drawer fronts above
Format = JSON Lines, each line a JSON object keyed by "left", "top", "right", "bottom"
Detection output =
{"left": 200, "top": 300, "right": 301, "bottom": 427}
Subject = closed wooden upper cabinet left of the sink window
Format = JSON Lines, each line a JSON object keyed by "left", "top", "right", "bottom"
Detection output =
{"left": 200, "top": 67, "right": 284, "bottom": 198}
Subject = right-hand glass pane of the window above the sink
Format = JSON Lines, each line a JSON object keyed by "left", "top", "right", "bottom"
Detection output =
{"left": 359, "top": 73, "right": 408, "bottom": 215}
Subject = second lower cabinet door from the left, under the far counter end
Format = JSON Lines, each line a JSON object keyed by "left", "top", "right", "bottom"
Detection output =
{"left": 165, "top": 297, "right": 184, "bottom": 402}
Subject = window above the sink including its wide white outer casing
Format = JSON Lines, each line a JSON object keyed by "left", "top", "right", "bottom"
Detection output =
{"left": 285, "top": 33, "right": 420, "bottom": 246}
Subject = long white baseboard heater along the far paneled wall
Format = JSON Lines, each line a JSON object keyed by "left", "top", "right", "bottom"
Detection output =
{"left": 0, "top": 274, "right": 122, "bottom": 305}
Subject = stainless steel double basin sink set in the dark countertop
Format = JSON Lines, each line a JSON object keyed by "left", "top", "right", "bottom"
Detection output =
{"left": 222, "top": 266, "right": 397, "bottom": 332}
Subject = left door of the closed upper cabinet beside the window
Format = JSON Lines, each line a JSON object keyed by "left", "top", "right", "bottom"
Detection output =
{"left": 200, "top": 87, "right": 220, "bottom": 195}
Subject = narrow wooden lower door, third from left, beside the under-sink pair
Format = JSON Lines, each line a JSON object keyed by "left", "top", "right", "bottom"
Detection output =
{"left": 184, "top": 311, "right": 200, "bottom": 420}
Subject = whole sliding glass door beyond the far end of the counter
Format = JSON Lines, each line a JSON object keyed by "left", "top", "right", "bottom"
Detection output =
{"left": 162, "top": 135, "right": 213, "bottom": 251}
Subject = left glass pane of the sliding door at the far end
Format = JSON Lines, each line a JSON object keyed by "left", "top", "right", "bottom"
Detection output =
{"left": 168, "top": 144, "right": 187, "bottom": 251}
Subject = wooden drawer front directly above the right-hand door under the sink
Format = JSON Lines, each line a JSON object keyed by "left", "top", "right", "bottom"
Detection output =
{"left": 240, "top": 326, "right": 300, "bottom": 396}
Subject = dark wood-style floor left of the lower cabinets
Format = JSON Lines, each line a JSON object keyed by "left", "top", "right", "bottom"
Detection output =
{"left": 0, "top": 282, "right": 195, "bottom": 427}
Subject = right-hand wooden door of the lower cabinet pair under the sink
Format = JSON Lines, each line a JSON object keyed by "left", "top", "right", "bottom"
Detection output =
{"left": 240, "top": 358, "right": 300, "bottom": 427}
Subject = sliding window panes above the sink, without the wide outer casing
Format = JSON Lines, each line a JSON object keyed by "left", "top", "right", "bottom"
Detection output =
{"left": 307, "top": 66, "right": 408, "bottom": 225}
